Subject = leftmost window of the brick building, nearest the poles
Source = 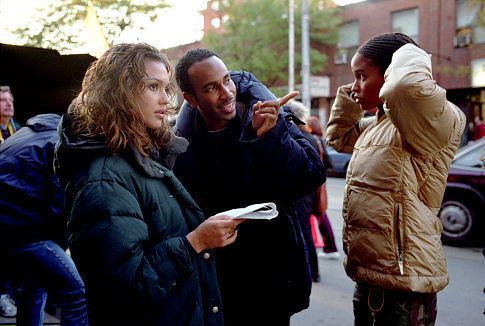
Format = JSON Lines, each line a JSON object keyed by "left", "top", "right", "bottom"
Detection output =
{"left": 333, "top": 21, "right": 359, "bottom": 65}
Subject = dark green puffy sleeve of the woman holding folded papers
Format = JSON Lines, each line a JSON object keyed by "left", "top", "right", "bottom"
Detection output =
{"left": 71, "top": 181, "right": 197, "bottom": 304}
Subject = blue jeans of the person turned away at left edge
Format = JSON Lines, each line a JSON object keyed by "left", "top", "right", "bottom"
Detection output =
{"left": 0, "top": 240, "right": 88, "bottom": 326}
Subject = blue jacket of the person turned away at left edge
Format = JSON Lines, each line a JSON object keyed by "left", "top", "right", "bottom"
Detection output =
{"left": 0, "top": 114, "right": 66, "bottom": 250}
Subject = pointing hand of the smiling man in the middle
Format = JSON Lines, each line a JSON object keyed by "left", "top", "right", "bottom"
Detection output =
{"left": 251, "top": 91, "right": 299, "bottom": 137}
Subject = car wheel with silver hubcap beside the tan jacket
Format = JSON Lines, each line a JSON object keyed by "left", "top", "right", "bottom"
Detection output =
{"left": 438, "top": 197, "right": 477, "bottom": 245}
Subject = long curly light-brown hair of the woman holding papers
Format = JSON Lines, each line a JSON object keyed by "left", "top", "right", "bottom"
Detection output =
{"left": 74, "top": 43, "right": 176, "bottom": 156}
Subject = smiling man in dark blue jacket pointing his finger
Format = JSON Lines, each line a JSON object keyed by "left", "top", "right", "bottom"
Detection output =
{"left": 174, "top": 49, "right": 325, "bottom": 326}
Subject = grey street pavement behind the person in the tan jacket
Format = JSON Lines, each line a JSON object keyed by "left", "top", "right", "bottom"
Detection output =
{"left": 291, "top": 178, "right": 485, "bottom": 326}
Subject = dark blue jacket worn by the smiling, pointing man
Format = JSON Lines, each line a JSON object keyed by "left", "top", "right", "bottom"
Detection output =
{"left": 174, "top": 72, "right": 325, "bottom": 321}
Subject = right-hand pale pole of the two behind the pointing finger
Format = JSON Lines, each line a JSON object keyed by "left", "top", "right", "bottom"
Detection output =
{"left": 301, "top": 0, "right": 311, "bottom": 109}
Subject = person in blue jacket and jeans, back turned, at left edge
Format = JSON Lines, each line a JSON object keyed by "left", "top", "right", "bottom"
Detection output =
{"left": 0, "top": 114, "right": 88, "bottom": 325}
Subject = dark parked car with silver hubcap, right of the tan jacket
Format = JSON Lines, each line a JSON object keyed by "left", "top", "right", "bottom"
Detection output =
{"left": 438, "top": 138, "right": 485, "bottom": 245}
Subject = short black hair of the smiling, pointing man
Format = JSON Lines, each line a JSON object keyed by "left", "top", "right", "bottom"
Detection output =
{"left": 175, "top": 49, "right": 220, "bottom": 95}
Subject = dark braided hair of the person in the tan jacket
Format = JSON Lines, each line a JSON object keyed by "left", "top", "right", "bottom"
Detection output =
{"left": 357, "top": 33, "right": 419, "bottom": 73}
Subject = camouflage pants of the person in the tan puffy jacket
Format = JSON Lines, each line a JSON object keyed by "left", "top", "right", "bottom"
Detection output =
{"left": 353, "top": 283, "right": 437, "bottom": 326}
